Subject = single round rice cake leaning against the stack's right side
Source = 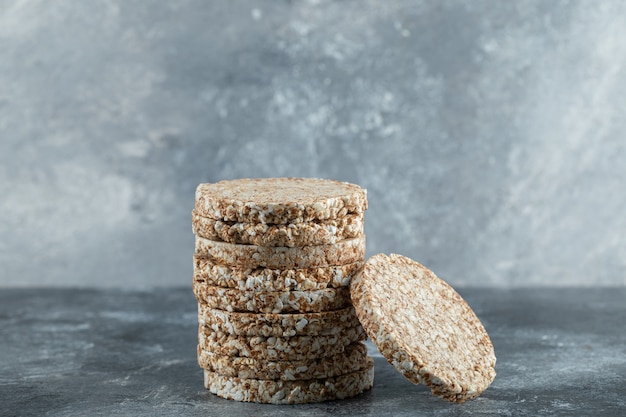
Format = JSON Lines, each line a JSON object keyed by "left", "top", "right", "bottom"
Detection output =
{"left": 350, "top": 254, "right": 496, "bottom": 401}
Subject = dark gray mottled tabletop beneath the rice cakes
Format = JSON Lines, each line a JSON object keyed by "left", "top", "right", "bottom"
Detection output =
{"left": 0, "top": 288, "right": 626, "bottom": 417}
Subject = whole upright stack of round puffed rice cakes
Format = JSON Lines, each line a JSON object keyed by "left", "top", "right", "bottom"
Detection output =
{"left": 192, "top": 178, "right": 374, "bottom": 404}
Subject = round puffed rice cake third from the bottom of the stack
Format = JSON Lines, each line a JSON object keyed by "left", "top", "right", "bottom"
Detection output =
{"left": 198, "top": 324, "right": 367, "bottom": 361}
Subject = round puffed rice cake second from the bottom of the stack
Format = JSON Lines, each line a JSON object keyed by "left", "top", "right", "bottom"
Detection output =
{"left": 198, "top": 342, "right": 368, "bottom": 381}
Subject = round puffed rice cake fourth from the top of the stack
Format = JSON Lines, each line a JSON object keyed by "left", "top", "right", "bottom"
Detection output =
{"left": 193, "top": 256, "right": 364, "bottom": 291}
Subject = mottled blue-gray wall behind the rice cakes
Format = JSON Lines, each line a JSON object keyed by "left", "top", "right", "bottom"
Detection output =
{"left": 0, "top": 0, "right": 626, "bottom": 286}
